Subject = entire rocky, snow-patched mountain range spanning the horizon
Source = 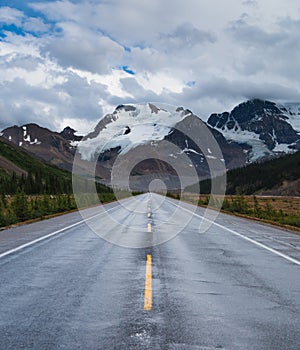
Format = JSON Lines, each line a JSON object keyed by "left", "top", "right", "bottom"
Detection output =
{"left": 1, "top": 99, "right": 300, "bottom": 190}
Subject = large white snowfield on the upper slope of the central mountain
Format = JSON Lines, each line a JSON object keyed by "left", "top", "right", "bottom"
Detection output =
{"left": 78, "top": 103, "right": 192, "bottom": 160}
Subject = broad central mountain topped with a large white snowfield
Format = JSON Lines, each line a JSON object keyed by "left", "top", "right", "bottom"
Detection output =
{"left": 78, "top": 103, "right": 246, "bottom": 190}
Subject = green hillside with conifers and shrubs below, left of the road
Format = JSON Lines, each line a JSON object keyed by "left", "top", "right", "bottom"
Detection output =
{"left": 0, "top": 142, "right": 117, "bottom": 227}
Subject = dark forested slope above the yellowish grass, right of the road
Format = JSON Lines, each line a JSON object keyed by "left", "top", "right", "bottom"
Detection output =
{"left": 186, "top": 151, "right": 300, "bottom": 196}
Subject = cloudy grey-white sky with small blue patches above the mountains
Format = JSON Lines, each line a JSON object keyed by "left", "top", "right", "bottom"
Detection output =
{"left": 0, "top": 0, "right": 300, "bottom": 134}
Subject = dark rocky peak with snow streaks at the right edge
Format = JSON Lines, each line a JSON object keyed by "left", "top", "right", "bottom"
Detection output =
{"left": 208, "top": 99, "right": 300, "bottom": 162}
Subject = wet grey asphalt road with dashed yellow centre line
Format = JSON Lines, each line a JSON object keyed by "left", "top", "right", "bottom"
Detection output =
{"left": 0, "top": 194, "right": 300, "bottom": 350}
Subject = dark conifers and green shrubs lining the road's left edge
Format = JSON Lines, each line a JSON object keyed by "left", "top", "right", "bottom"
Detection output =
{"left": 0, "top": 169, "right": 115, "bottom": 227}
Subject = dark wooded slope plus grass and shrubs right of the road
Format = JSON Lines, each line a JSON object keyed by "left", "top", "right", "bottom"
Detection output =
{"left": 180, "top": 151, "right": 300, "bottom": 228}
